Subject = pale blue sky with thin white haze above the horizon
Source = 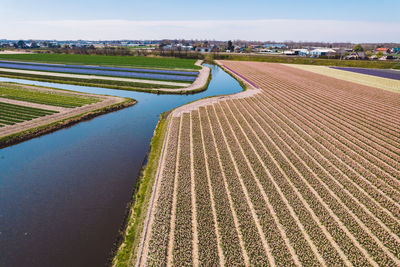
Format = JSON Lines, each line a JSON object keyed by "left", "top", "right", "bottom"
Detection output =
{"left": 0, "top": 0, "right": 400, "bottom": 43}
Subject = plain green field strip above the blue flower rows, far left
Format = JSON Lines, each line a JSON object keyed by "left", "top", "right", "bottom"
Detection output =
{"left": 0, "top": 54, "right": 201, "bottom": 70}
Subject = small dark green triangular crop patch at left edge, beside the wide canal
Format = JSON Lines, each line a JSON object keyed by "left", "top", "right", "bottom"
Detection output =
{"left": 0, "top": 102, "right": 58, "bottom": 127}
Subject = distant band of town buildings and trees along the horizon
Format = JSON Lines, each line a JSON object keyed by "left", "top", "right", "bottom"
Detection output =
{"left": 0, "top": 39, "right": 400, "bottom": 61}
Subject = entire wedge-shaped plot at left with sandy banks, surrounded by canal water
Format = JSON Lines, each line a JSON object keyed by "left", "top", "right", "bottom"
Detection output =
{"left": 0, "top": 83, "right": 136, "bottom": 148}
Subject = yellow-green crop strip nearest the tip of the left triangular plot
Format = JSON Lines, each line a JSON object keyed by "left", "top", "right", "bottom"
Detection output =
{"left": 0, "top": 83, "right": 99, "bottom": 108}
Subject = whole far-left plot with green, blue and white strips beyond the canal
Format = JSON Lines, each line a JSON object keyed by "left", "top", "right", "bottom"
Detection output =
{"left": 0, "top": 54, "right": 209, "bottom": 94}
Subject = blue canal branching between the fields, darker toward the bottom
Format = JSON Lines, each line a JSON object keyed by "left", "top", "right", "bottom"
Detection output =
{"left": 0, "top": 65, "right": 242, "bottom": 266}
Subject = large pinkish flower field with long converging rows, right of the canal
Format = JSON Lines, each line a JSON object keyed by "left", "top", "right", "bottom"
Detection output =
{"left": 137, "top": 61, "right": 400, "bottom": 266}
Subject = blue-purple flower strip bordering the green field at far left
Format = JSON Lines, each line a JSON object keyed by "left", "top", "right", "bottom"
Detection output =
{"left": 0, "top": 62, "right": 196, "bottom": 82}
